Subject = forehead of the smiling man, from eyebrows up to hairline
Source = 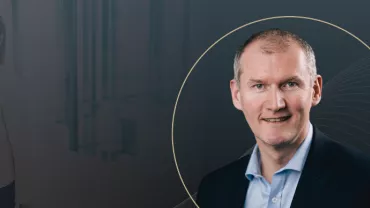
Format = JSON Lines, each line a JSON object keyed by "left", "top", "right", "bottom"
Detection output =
{"left": 240, "top": 40, "right": 309, "bottom": 79}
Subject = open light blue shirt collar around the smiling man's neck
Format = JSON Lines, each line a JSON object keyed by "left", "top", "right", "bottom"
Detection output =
{"left": 245, "top": 122, "right": 313, "bottom": 180}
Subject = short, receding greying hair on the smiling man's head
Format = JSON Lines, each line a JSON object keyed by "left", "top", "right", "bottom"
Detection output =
{"left": 234, "top": 28, "right": 317, "bottom": 86}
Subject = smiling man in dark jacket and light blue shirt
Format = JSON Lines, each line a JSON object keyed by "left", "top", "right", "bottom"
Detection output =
{"left": 197, "top": 29, "right": 370, "bottom": 208}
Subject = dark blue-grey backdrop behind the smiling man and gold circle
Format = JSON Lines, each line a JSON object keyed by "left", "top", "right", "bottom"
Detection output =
{"left": 0, "top": 0, "right": 370, "bottom": 208}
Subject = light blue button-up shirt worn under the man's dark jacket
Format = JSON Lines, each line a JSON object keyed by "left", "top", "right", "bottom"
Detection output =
{"left": 244, "top": 122, "right": 313, "bottom": 208}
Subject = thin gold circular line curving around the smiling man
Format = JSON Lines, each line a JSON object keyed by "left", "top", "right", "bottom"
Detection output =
{"left": 171, "top": 16, "right": 370, "bottom": 208}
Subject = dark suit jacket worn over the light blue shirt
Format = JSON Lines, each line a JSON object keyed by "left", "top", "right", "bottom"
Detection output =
{"left": 197, "top": 126, "right": 370, "bottom": 208}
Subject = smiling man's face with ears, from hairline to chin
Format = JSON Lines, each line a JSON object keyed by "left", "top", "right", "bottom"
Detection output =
{"left": 230, "top": 40, "right": 322, "bottom": 147}
